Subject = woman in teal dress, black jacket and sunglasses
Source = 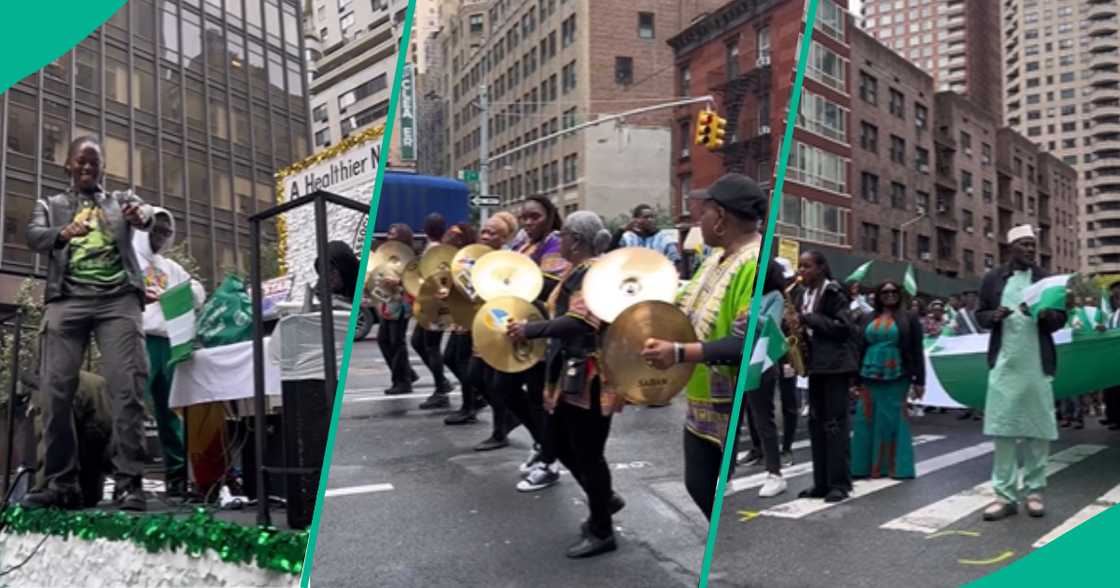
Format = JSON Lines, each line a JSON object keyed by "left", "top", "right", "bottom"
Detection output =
{"left": 851, "top": 281, "right": 925, "bottom": 479}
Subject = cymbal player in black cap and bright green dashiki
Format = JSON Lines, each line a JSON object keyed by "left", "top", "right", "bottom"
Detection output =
{"left": 642, "top": 174, "right": 766, "bottom": 519}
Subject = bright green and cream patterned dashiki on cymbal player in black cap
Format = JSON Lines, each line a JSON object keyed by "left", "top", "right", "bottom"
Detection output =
{"left": 678, "top": 240, "right": 762, "bottom": 447}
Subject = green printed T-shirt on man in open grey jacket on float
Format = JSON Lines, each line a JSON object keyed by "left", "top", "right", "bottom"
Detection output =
{"left": 66, "top": 195, "right": 129, "bottom": 290}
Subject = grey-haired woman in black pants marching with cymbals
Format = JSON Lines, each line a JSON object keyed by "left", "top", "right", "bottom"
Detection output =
{"left": 508, "top": 211, "right": 625, "bottom": 558}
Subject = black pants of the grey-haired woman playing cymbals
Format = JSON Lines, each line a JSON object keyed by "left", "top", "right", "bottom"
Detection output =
{"left": 553, "top": 396, "right": 614, "bottom": 539}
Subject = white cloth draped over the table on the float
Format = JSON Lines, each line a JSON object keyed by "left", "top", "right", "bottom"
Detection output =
{"left": 169, "top": 337, "right": 280, "bottom": 408}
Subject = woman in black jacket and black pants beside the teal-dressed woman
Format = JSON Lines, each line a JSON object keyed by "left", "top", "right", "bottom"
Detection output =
{"left": 794, "top": 251, "right": 858, "bottom": 502}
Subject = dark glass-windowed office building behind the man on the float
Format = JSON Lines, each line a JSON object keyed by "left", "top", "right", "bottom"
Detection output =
{"left": 0, "top": 0, "right": 309, "bottom": 287}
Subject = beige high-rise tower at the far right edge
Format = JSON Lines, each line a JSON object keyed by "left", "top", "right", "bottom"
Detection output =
{"left": 1001, "top": 0, "right": 1120, "bottom": 273}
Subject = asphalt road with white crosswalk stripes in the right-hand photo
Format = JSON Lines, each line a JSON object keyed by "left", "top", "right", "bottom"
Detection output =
{"left": 710, "top": 407, "right": 1120, "bottom": 588}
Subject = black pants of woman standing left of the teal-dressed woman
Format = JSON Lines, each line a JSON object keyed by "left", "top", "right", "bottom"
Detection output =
{"left": 809, "top": 374, "right": 851, "bottom": 495}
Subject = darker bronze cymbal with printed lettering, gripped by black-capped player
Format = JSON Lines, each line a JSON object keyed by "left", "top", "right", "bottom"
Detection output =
{"left": 603, "top": 300, "right": 697, "bottom": 405}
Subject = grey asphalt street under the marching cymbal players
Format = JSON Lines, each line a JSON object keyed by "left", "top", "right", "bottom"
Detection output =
{"left": 312, "top": 343, "right": 708, "bottom": 588}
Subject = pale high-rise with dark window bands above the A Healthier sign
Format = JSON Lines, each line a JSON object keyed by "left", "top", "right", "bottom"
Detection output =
{"left": 304, "top": 0, "right": 409, "bottom": 150}
